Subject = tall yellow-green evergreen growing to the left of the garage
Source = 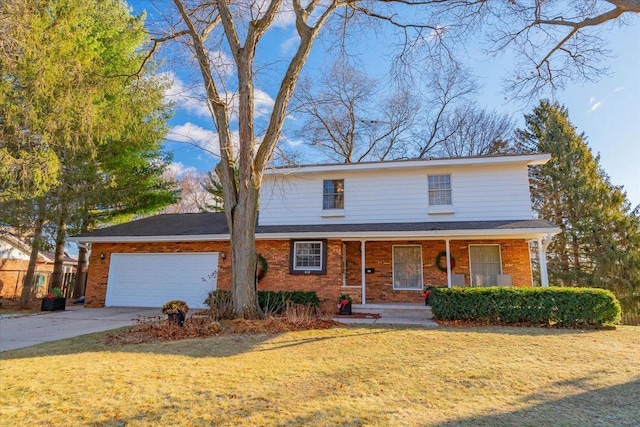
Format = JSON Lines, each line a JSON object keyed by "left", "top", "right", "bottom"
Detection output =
{"left": 0, "top": 0, "right": 175, "bottom": 305}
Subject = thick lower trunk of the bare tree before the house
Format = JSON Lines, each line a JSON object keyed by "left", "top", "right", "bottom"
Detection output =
{"left": 231, "top": 185, "right": 264, "bottom": 319}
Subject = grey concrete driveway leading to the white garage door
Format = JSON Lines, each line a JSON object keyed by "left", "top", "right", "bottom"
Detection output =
{"left": 0, "top": 306, "right": 163, "bottom": 351}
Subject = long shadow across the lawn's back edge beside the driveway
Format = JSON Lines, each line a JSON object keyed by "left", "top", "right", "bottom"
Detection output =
{"left": 0, "top": 327, "right": 391, "bottom": 360}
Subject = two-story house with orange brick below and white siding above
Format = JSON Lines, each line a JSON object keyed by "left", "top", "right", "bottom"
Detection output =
{"left": 74, "top": 154, "right": 560, "bottom": 307}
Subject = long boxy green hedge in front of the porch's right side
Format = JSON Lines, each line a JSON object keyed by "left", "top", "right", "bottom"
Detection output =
{"left": 430, "top": 287, "right": 621, "bottom": 327}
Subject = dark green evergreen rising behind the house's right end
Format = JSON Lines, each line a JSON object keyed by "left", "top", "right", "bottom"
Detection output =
{"left": 517, "top": 101, "right": 640, "bottom": 312}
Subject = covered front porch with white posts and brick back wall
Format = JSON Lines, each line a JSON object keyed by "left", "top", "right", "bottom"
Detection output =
{"left": 340, "top": 221, "right": 556, "bottom": 307}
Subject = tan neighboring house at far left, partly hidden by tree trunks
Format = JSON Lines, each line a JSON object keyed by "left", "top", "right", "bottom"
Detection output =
{"left": 0, "top": 232, "right": 77, "bottom": 298}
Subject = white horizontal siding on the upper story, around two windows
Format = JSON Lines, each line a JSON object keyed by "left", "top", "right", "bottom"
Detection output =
{"left": 259, "top": 164, "right": 532, "bottom": 225}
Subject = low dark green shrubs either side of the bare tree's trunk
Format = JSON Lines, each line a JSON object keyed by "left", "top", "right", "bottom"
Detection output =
{"left": 204, "top": 290, "right": 320, "bottom": 319}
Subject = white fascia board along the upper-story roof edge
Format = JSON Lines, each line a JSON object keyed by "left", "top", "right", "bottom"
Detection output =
{"left": 264, "top": 153, "right": 551, "bottom": 175}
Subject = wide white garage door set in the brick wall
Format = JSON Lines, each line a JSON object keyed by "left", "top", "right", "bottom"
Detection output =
{"left": 105, "top": 252, "right": 218, "bottom": 308}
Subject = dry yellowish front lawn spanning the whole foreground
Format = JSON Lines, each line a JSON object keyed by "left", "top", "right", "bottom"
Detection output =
{"left": 0, "top": 327, "right": 640, "bottom": 426}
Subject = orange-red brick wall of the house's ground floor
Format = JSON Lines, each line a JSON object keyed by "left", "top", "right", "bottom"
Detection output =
{"left": 85, "top": 239, "right": 532, "bottom": 307}
